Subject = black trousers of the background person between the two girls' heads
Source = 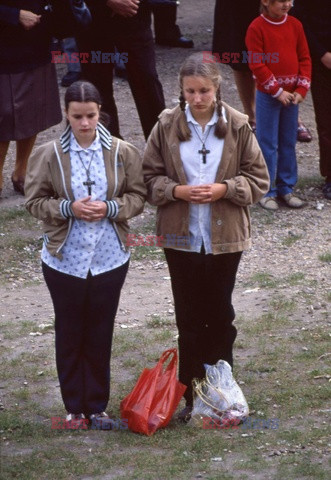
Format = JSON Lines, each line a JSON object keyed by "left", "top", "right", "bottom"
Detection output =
{"left": 76, "top": 2, "right": 165, "bottom": 139}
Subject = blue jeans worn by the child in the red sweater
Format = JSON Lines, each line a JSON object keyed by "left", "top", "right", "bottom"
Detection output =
{"left": 256, "top": 90, "right": 298, "bottom": 197}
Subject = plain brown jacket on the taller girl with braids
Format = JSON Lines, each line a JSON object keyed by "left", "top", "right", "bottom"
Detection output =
{"left": 143, "top": 104, "right": 269, "bottom": 254}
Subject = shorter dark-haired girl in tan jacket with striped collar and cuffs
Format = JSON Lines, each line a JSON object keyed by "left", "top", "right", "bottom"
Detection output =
{"left": 26, "top": 82, "right": 145, "bottom": 429}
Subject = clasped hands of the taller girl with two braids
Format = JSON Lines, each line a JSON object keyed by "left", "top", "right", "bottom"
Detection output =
{"left": 174, "top": 183, "right": 228, "bottom": 204}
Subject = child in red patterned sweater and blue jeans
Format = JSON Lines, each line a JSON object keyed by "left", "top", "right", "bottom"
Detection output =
{"left": 246, "top": 0, "right": 311, "bottom": 210}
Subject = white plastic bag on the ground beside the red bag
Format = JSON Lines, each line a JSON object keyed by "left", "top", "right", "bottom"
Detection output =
{"left": 189, "top": 360, "right": 249, "bottom": 428}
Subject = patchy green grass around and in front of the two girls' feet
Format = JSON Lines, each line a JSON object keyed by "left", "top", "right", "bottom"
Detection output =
{"left": 0, "top": 204, "right": 331, "bottom": 480}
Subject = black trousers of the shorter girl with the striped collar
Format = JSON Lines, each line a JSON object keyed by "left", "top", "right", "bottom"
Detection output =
{"left": 42, "top": 262, "right": 129, "bottom": 415}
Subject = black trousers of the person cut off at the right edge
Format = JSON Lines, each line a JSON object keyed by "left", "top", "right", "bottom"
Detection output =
{"left": 311, "top": 62, "right": 331, "bottom": 182}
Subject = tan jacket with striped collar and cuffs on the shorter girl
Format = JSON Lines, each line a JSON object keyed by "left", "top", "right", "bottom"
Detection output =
{"left": 24, "top": 137, "right": 146, "bottom": 258}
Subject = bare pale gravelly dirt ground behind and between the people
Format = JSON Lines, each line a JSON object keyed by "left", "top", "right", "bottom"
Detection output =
{"left": 0, "top": 0, "right": 331, "bottom": 476}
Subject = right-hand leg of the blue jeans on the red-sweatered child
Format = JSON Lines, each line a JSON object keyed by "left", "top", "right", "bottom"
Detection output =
{"left": 276, "top": 105, "right": 298, "bottom": 196}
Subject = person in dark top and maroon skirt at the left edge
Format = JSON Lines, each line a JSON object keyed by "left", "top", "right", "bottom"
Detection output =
{"left": 0, "top": 0, "right": 62, "bottom": 196}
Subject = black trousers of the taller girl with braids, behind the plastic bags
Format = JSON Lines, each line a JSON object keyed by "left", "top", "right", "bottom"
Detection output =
{"left": 165, "top": 249, "right": 242, "bottom": 405}
